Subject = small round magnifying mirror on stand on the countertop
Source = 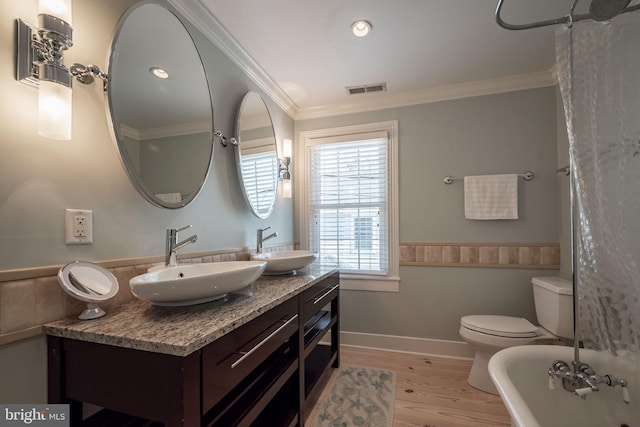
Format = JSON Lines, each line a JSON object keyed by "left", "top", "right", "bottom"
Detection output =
{"left": 58, "top": 261, "right": 119, "bottom": 320}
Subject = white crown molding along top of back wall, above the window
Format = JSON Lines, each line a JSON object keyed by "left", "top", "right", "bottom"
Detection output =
{"left": 296, "top": 71, "right": 556, "bottom": 120}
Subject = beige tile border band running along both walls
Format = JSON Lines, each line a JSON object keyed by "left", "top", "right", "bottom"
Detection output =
{"left": 0, "top": 242, "right": 560, "bottom": 345}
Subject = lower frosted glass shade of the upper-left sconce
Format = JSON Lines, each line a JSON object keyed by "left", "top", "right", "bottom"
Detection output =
{"left": 38, "top": 80, "right": 72, "bottom": 140}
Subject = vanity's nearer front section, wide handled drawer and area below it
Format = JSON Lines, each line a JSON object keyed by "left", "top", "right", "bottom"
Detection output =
{"left": 202, "top": 298, "right": 299, "bottom": 427}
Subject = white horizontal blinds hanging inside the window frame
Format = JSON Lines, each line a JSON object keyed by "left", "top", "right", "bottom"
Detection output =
{"left": 308, "top": 132, "right": 389, "bottom": 274}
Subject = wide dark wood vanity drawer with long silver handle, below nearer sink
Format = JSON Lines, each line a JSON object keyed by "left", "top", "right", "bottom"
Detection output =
{"left": 202, "top": 298, "right": 299, "bottom": 414}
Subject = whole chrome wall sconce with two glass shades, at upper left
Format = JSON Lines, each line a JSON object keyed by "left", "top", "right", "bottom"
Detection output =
{"left": 16, "top": 0, "right": 107, "bottom": 139}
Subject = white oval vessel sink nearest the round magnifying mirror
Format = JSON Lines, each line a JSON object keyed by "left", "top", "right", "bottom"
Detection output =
{"left": 129, "top": 261, "right": 267, "bottom": 306}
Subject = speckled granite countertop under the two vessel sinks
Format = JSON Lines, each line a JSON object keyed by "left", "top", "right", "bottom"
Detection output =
{"left": 44, "top": 269, "right": 337, "bottom": 356}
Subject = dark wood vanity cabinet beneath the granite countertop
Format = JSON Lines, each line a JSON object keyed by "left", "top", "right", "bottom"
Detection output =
{"left": 48, "top": 273, "right": 339, "bottom": 427}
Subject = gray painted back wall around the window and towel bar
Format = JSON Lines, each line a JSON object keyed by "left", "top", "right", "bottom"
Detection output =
{"left": 296, "top": 87, "right": 559, "bottom": 341}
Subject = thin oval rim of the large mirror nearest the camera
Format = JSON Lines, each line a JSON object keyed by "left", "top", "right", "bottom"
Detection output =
{"left": 106, "top": 1, "right": 215, "bottom": 209}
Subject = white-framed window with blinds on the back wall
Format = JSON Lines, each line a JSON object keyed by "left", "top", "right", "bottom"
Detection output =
{"left": 300, "top": 122, "right": 399, "bottom": 291}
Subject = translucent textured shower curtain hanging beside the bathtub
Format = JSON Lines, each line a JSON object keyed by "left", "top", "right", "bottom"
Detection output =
{"left": 556, "top": 11, "right": 640, "bottom": 360}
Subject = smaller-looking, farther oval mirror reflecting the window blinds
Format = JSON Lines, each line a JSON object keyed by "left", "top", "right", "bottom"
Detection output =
{"left": 236, "top": 92, "right": 278, "bottom": 219}
